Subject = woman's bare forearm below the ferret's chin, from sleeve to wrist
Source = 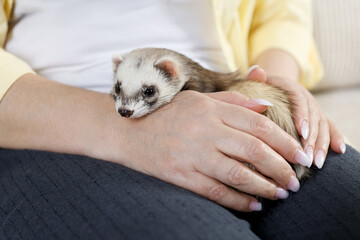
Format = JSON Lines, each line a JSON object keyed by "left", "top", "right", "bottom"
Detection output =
{"left": 0, "top": 74, "right": 126, "bottom": 160}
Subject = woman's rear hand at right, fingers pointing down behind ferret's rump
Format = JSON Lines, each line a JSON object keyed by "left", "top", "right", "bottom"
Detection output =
{"left": 248, "top": 64, "right": 346, "bottom": 169}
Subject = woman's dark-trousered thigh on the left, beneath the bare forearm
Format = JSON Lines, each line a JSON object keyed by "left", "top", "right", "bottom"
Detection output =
{"left": 0, "top": 150, "right": 257, "bottom": 239}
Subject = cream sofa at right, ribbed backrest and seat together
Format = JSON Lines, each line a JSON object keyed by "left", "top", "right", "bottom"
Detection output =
{"left": 312, "top": 0, "right": 360, "bottom": 150}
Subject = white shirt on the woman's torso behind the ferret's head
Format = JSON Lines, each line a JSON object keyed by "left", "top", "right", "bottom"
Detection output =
{"left": 6, "top": 0, "right": 228, "bottom": 92}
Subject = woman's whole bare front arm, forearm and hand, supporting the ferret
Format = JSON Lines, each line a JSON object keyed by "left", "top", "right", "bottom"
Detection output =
{"left": 0, "top": 74, "right": 307, "bottom": 211}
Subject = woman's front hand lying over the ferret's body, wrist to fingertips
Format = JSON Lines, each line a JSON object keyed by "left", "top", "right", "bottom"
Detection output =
{"left": 105, "top": 91, "right": 307, "bottom": 211}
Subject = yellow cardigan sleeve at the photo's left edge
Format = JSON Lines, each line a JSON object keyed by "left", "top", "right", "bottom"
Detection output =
{"left": 0, "top": 0, "right": 34, "bottom": 101}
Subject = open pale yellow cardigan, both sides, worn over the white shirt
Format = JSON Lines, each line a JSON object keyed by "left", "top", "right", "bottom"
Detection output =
{"left": 0, "top": 0, "right": 322, "bottom": 100}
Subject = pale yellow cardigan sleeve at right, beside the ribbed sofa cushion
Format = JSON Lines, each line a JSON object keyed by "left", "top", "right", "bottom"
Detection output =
{"left": 249, "top": 0, "right": 323, "bottom": 88}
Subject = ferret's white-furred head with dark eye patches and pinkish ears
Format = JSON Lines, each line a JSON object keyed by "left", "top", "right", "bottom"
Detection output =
{"left": 111, "top": 49, "right": 184, "bottom": 118}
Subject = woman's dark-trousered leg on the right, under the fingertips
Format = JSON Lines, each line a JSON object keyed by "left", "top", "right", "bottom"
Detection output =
{"left": 242, "top": 146, "right": 360, "bottom": 240}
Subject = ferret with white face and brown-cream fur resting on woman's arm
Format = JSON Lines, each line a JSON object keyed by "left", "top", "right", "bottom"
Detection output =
{"left": 111, "top": 48, "right": 308, "bottom": 179}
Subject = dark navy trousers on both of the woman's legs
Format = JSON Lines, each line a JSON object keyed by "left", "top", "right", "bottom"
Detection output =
{"left": 0, "top": 146, "right": 360, "bottom": 240}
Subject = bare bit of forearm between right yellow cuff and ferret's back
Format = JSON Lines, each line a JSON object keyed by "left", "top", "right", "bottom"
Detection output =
{"left": 253, "top": 49, "right": 299, "bottom": 82}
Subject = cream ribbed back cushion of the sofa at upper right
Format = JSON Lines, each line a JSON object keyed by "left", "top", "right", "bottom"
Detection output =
{"left": 312, "top": 0, "right": 360, "bottom": 90}
